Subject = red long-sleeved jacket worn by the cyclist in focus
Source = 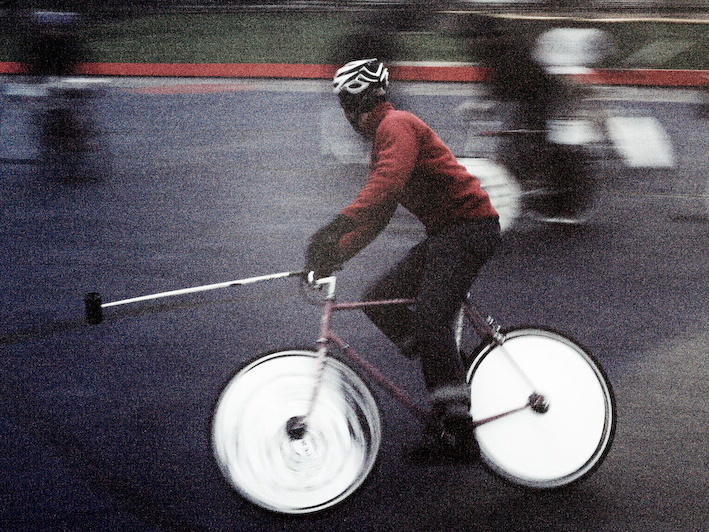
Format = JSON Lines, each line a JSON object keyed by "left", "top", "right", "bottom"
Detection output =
{"left": 339, "top": 102, "right": 497, "bottom": 259}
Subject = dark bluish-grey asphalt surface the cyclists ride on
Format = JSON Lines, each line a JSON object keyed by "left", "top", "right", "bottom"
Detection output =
{"left": 0, "top": 79, "right": 709, "bottom": 532}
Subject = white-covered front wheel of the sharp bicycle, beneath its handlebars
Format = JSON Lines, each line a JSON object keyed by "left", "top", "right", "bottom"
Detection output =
{"left": 212, "top": 350, "right": 381, "bottom": 514}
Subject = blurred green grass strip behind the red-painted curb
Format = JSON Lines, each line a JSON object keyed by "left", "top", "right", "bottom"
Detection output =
{"left": 0, "top": 12, "right": 709, "bottom": 70}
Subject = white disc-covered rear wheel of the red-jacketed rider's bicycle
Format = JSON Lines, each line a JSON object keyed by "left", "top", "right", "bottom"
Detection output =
{"left": 468, "top": 329, "right": 616, "bottom": 489}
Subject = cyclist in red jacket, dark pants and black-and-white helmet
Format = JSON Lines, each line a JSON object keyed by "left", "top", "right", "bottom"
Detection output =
{"left": 306, "top": 59, "right": 500, "bottom": 461}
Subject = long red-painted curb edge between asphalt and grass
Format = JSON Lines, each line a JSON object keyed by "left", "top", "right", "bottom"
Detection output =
{"left": 0, "top": 62, "right": 709, "bottom": 90}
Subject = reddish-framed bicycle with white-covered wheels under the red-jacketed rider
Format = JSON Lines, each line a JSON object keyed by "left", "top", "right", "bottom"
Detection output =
{"left": 210, "top": 272, "right": 616, "bottom": 514}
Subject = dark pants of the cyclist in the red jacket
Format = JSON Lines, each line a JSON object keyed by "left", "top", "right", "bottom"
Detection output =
{"left": 364, "top": 219, "right": 500, "bottom": 392}
